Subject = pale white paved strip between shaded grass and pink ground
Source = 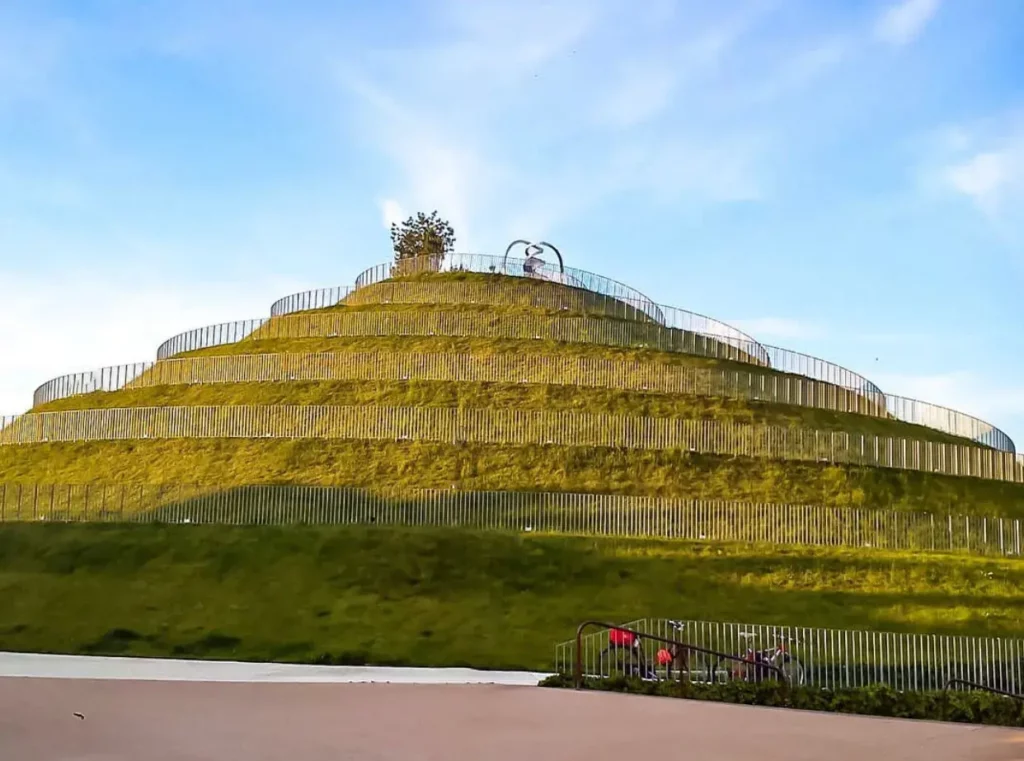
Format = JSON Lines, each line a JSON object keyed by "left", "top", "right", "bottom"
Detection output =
{"left": 0, "top": 652, "right": 548, "bottom": 686}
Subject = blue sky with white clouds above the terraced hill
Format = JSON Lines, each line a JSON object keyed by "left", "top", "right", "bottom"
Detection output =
{"left": 0, "top": 0, "right": 1024, "bottom": 445}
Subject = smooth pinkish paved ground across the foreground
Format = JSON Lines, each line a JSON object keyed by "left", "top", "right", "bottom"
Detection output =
{"left": 0, "top": 678, "right": 1024, "bottom": 761}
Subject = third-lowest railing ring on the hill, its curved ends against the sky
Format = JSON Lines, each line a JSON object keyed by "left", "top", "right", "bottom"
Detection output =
{"left": 33, "top": 351, "right": 1015, "bottom": 449}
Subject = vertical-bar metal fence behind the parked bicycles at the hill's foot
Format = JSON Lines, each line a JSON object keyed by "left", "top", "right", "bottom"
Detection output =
{"left": 555, "top": 619, "right": 1024, "bottom": 692}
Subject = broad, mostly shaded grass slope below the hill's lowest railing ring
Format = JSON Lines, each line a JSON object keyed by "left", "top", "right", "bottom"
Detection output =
{"left": 0, "top": 525, "right": 1024, "bottom": 669}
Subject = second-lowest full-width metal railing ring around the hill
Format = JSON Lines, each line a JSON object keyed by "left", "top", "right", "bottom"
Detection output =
{"left": 0, "top": 406, "right": 1024, "bottom": 483}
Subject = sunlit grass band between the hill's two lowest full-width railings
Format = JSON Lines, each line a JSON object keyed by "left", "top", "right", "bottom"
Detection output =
{"left": 0, "top": 439, "right": 1024, "bottom": 517}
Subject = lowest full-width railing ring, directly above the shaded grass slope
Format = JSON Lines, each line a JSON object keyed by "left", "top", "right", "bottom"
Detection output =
{"left": 0, "top": 482, "right": 1024, "bottom": 557}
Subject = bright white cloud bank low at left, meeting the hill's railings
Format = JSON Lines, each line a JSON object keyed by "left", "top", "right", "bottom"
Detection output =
{"left": 0, "top": 271, "right": 310, "bottom": 415}
